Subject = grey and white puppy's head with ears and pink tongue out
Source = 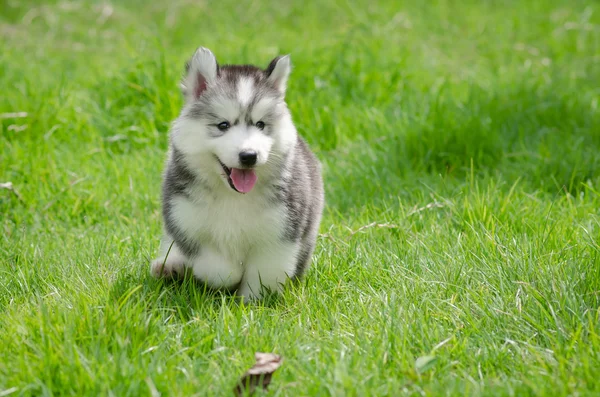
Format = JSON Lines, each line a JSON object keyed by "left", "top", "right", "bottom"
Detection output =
{"left": 172, "top": 47, "right": 296, "bottom": 193}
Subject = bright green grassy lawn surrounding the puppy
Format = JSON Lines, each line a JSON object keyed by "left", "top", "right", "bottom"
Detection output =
{"left": 0, "top": 0, "right": 600, "bottom": 396}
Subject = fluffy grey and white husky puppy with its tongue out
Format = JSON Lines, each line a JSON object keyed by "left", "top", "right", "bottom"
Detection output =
{"left": 151, "top": 47, "right": 324, "bottom": 300}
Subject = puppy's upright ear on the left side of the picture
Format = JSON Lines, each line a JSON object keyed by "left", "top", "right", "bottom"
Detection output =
{"left": 181, "top": 47, "right": 219, "bottom": 102}
